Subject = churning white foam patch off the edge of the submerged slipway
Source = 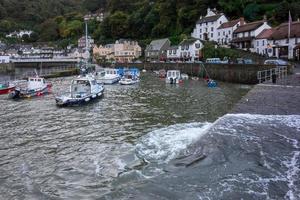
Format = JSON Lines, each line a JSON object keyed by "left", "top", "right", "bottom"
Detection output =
{"left": 136, "top": 123, "right": 212, "bottom": 163}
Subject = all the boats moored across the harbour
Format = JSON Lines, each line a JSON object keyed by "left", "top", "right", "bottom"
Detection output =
{"left": 0, "top": 68, "right": 216, "bottom": 106}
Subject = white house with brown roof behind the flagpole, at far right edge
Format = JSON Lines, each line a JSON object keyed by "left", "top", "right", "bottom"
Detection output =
{"left": 269, "top": 21, "right": 300, "bottom": 60}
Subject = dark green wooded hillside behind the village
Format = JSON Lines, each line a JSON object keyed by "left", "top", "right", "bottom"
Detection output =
{"left": 0, "top": 0, "right": 300, "bottom": 45}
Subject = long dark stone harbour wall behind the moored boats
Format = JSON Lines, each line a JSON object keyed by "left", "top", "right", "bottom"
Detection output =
{"left": 108, "top": 63, "right": 291, "bottom": 84}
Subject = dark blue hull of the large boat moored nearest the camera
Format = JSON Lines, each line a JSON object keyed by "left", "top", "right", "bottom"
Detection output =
{"left": 55, "top": 90, "right": 104, "bottom": 107}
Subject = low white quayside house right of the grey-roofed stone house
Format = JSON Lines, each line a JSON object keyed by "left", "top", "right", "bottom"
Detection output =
{"left": 178, "top": 39, "right": 203, "bottom": 61}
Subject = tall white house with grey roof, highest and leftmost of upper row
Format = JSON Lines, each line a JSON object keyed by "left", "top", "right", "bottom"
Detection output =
{"left": 191, "top": 8, "right": 228, "bottom": 42}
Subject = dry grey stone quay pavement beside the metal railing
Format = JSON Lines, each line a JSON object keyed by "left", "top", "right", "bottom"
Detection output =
{"left": 231, "top": 64, "right": 300, "bottom": 115}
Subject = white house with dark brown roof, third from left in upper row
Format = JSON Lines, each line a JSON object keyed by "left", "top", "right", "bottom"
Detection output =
{"left": 231, "top": 19, "right": 271, "bottom": 52}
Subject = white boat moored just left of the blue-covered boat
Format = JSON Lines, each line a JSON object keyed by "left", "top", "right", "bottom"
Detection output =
{"left": 95, "top": 68, "right": 120, "bottom": 85}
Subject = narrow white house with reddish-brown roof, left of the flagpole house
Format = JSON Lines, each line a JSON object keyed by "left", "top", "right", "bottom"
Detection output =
{"left": 254, "top": 29, "right": 273, "bottom": 57}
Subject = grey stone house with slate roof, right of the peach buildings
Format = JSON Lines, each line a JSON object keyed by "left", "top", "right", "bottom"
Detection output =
{"left": 145, "top": 38, "right": 171, "bottom": 62}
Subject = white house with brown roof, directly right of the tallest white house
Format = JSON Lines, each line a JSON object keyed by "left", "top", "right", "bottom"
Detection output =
{"left": 217, "top": 18, "right": 245, "bottom": 45}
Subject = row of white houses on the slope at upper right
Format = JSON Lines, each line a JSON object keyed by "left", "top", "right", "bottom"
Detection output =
{"left": 191, "top": 8, "right": 300, "bottom": 60}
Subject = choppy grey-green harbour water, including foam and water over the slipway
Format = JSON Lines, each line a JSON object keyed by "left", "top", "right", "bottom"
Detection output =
{"left": 0, "top": 74, "right": 284, "bottom": 199}
